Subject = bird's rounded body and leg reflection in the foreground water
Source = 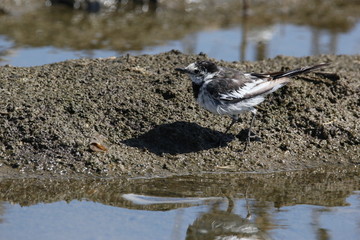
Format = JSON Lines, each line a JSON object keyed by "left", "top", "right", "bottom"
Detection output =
{"left": 186, "top": 197, "right": 271, "bottom": 240}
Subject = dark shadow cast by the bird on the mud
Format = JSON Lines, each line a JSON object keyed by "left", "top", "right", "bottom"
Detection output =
{"left": 123, "top": 122, "right": 234, "bottom": 155}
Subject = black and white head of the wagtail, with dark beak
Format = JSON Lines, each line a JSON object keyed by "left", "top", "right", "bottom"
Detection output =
{"left": 175, "top": 61, "right": 219, "bottom": 85}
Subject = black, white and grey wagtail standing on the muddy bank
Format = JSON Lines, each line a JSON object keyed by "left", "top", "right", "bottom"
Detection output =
{"left": 175, "top": 61, "right": 328, "bottom": 149}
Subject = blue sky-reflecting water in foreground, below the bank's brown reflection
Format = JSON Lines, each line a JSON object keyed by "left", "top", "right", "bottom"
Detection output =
{"left": 0, "top": 192, "right": 360, "bottom": 240}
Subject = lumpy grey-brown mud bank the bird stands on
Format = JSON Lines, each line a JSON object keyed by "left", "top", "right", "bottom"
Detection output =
{"left": 0, "top": 51, "right": 360, "bottom": 177}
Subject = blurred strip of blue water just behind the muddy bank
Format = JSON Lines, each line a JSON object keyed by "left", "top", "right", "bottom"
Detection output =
{"left": 0, "top": 23, "right": 360, "bottom": 67}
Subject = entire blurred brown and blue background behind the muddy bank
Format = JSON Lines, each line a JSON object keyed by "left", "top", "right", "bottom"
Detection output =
{"left": 0, "top": 0, "right": 360, "bottom": 66}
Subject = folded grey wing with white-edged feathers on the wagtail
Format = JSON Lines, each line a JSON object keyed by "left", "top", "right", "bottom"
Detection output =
{"left": 204, "top": 71, "right": 290, "bottom": 103}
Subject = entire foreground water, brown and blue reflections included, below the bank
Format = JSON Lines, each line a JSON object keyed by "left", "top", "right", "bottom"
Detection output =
{"left": 0, "top": 170, "right": 360, "bottom": 240}
